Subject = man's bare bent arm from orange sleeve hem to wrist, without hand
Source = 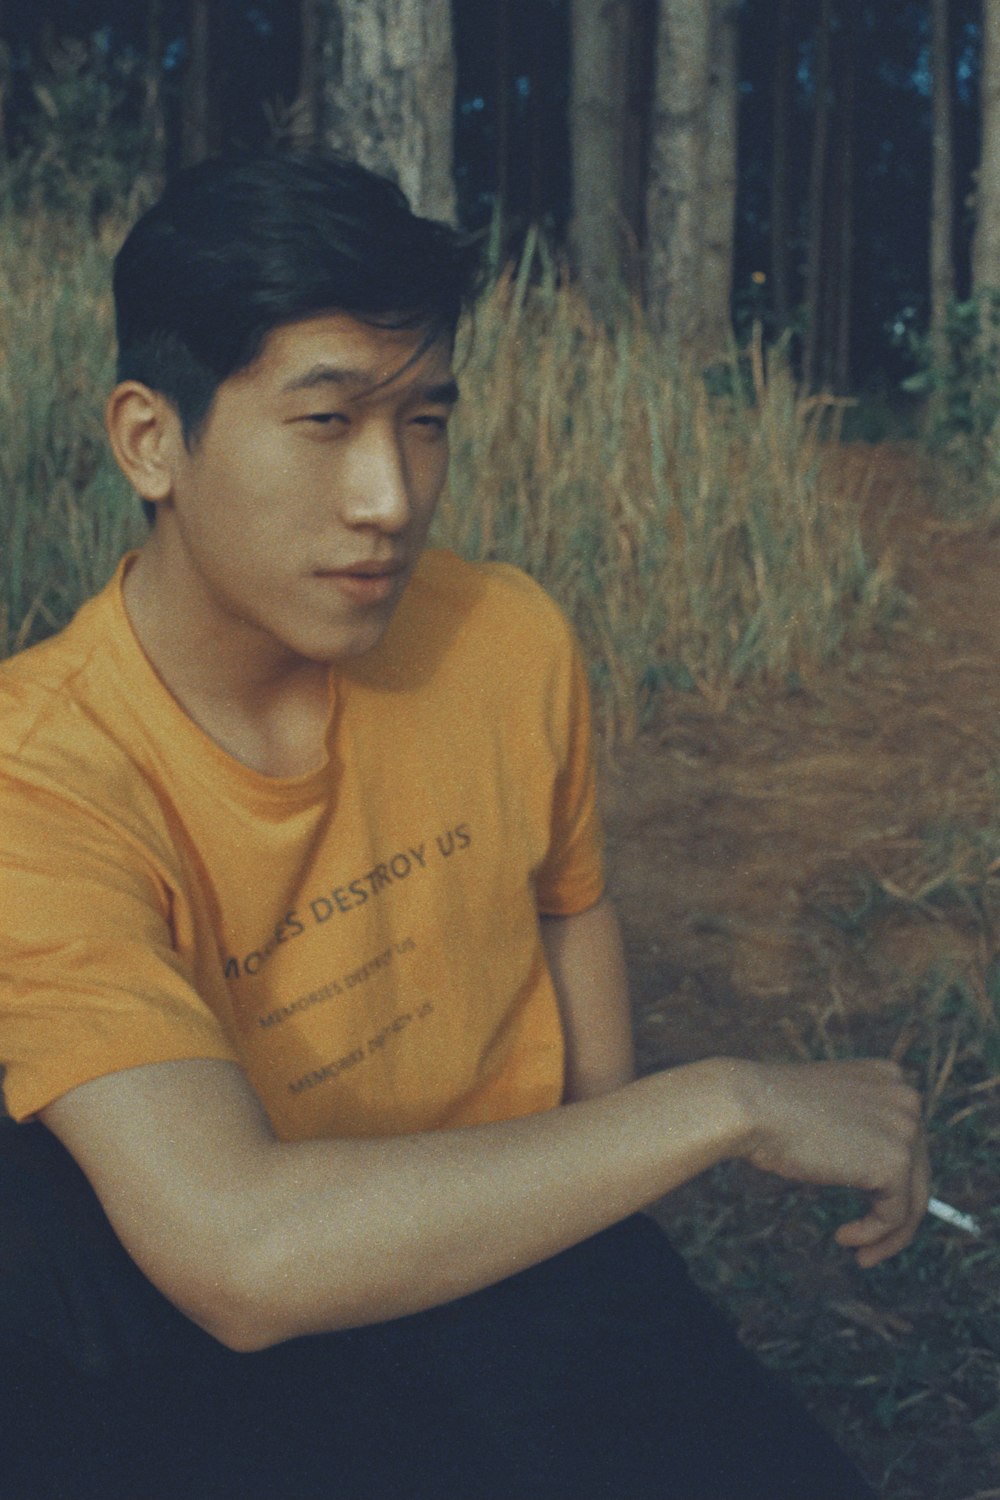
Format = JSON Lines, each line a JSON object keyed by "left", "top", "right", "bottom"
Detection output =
{"left": 45, "top": 1061, "right": 745, "bottom": 1349}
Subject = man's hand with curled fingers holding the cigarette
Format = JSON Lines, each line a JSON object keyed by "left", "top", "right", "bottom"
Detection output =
{"left": 738, "top": 1061, "right": 930, "bottom": 1266}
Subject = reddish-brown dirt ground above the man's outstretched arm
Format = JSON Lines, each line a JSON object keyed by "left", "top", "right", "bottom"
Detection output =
{"left": 604, "top": 446, "right": 1000, "bottom": 1067}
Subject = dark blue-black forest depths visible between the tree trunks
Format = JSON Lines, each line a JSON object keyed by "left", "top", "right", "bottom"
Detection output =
{"left": 0, "top": 0, "right": 981, "bottom": 390}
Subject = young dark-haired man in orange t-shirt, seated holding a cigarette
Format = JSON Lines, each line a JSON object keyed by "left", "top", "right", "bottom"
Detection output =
{"left": 0, "top": 156, "right": 927, "bottom": 1500}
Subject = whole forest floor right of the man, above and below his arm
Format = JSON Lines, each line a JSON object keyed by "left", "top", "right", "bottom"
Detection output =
{"left": 604, "top": 446, "right": 1000, "bottom": 1500}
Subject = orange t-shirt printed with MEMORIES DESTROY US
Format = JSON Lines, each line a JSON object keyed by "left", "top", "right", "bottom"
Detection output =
{"left": 0, "top": 552, "right": 603, "bottom": 1140}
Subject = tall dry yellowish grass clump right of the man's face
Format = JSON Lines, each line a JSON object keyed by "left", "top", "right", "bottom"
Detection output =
{"left": 436, "top": 246, "right": 892, "bottom": 735}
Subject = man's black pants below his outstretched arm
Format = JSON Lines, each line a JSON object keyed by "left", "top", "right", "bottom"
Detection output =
{"left": 0, "top": 1122, "right": 871, "bottom": 1500}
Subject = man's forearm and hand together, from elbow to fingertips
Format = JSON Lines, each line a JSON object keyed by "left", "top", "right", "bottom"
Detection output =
{"left": 244, "top": 1058, "right": 928, "bottom": 1341}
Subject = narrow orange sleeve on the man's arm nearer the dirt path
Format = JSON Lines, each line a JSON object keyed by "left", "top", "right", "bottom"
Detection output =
{"left": 535, "top": 620, "right": 604, "bottom": 917}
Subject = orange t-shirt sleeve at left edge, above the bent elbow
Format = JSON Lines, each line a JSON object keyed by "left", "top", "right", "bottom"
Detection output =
{"left": 0, "top": 776, "right": 235, "bottom": 1121}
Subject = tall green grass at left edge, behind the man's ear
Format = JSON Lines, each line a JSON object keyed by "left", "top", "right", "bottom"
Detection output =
{"left": 0, "top": 212, "right": 139, "bottom": 653}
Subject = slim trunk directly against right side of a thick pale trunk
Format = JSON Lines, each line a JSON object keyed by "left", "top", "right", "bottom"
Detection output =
{"left": 702, "top": 0, "right": 739, "bottom": 359}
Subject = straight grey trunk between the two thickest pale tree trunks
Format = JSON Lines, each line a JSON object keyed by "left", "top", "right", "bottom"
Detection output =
{"left": 570, "top": 0, "right": 628, "bottom": 318}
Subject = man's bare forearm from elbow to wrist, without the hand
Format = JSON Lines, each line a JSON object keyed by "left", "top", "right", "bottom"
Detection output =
{"left": 240, "top": 1062, "right": 747, "bottom": 1346}
